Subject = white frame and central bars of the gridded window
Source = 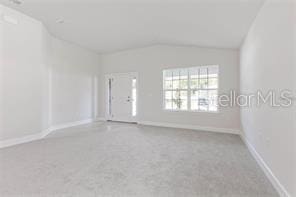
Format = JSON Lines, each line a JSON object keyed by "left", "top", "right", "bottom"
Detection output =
{"left": 162, "top": 65, "right": 220, "bottom": 113}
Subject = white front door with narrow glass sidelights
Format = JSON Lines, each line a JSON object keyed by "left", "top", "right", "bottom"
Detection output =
{"left": 107, "top": 73, "right": 137, "bottom": 122}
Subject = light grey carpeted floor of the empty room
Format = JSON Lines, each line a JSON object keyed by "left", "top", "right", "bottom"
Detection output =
{"left": 0, "top": 122, "right": 277, "bottom": 197}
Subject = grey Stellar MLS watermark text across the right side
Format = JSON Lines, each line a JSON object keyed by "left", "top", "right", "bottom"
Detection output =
{"left": 218, "top": 90, "right": 296, "bottom": 108}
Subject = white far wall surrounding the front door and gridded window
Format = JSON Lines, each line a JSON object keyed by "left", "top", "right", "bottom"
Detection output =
{"left": 101, "top": 45, "right": 240, "bottom": 130}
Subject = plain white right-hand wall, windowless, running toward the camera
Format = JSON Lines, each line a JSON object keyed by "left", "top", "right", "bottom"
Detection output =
{"left": 240, "top": 0, "right": 296, "bottom": 196}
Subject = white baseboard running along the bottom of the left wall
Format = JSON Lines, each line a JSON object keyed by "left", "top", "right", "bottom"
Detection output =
{"left": 0, "top": 119, "right": 93, "bottom": 148}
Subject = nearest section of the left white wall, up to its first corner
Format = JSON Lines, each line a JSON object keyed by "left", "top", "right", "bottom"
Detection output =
{"left": 0, "top": 5, "right": 48, "bottom": 140}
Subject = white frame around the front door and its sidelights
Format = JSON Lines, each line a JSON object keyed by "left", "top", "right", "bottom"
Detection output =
{"left": 104, "top": 72, "right": 139, "bottom": 123}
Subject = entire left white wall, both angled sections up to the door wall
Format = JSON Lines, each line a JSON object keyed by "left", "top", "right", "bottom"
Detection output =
{"left": 0, "top": 5, "right": 99, "bottom": 141}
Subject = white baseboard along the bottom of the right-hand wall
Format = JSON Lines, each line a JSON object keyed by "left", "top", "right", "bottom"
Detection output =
{"left": 241, "top": 135, "right": 291, "bottom": 197}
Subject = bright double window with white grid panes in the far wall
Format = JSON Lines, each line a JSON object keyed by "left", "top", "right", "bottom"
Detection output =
{"left": 163, "top": 66, "right": 219, "bottom": 112}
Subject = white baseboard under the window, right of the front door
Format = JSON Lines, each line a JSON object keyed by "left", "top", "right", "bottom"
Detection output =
{"left": 138, "top": 121, "right": 240, "bottom": 134}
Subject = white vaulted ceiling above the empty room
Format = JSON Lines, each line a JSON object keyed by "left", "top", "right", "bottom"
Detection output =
{"left": 0, "top": 0, "right": 264, "bottom": 53}
